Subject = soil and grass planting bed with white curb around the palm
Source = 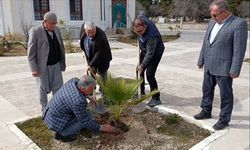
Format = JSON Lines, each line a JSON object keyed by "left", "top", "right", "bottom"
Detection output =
{"left": 17, "top": 109, "right": 210, "bottom": 150}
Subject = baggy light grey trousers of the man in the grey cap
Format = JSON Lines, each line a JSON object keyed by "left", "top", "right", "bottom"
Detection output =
{"left": 37, "top": 62, "right": 63, "bottom": 108}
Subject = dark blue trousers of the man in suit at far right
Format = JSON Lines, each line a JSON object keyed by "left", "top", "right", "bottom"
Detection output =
{"left": 201, "top": 72, "right": 234, "bottom": 123}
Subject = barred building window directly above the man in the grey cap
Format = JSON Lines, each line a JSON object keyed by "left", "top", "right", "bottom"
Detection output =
{"left": 33, "top": 0, "right": 50, "bottom": 20}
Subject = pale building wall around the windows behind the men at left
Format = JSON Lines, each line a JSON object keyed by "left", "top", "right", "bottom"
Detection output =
{"left": 0, "top": 0, "right": 135, "bottom": 36}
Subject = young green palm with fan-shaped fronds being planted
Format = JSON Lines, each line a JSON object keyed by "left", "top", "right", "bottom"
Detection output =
{"left": 95, "top": 74, "right": 158, "bottom": 120}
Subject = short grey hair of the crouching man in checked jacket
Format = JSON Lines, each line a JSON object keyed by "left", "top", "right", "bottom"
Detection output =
{"left": 77, "top": 75, "right": 96, "bottom": 89}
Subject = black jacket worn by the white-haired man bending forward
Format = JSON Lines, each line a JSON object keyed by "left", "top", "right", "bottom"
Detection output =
{"left": 80, "top": 24, "right": 112, "bottom": 74}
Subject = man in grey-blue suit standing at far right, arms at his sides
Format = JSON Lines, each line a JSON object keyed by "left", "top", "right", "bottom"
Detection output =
{"left": 194, "top": 0, "right": 247, "bottom": 130}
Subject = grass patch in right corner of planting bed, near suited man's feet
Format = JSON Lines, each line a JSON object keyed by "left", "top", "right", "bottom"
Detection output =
{"left": 157, "top": 114, "right": 210, "bottom": 143}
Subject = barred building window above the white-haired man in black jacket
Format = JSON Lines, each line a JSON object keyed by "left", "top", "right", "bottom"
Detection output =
{"left": 69, "top": 0, "right": 82, "bottom": 20}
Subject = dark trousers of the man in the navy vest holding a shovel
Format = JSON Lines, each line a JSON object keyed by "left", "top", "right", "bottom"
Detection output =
{"left": 140, "top": 53, "right": 162, "bottom": 99}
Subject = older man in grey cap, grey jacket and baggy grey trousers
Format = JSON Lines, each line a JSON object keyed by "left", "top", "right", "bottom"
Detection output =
{"left": 28, "top": 12, "right": 66, "bottom": 110}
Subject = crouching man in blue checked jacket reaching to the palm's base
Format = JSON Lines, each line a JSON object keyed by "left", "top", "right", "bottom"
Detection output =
{"left": 43, "top": 75, "right": 116, "bottom": 142}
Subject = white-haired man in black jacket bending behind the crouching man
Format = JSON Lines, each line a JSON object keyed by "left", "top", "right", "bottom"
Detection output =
{"left": 80, "top": 21, "right": 112, "bottom": 80}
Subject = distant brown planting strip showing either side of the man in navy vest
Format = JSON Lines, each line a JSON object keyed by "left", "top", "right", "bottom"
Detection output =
{"left": 117, "top": 35, "right": 180, "bottom": 46}
